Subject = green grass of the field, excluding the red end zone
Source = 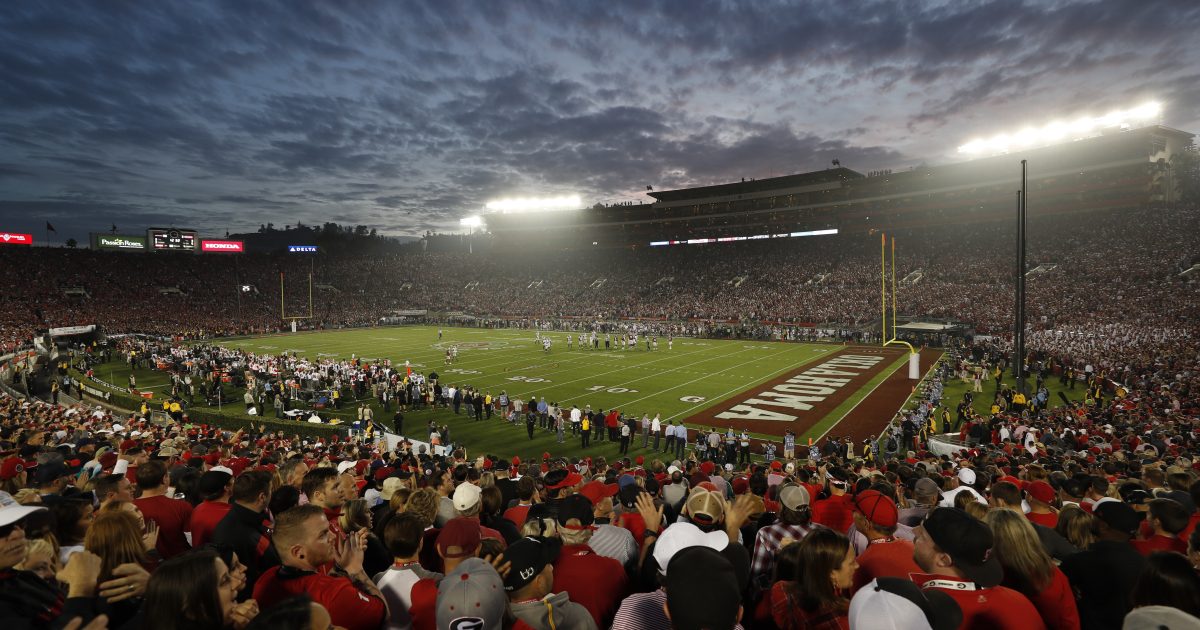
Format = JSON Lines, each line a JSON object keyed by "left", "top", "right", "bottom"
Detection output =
{"left": 87, "top": 326, "right": 904, "bottom": 458}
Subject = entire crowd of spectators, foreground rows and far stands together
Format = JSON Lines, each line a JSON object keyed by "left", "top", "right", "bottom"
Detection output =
{"left": 0, "top": 205, "right": 1200, "bottom": 630}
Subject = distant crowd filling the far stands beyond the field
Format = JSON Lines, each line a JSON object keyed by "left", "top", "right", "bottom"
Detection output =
{"left": 0, "top": 208, "right": 1200, "bottom": 362}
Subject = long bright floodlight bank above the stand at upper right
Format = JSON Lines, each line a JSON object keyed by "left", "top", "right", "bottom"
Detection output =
{"left": 959, "top": 101, "right": 1163, "bottom": 157}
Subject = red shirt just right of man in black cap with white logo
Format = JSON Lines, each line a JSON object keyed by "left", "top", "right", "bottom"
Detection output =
{"left": 552, "top": 545, "right": 629, "bottom": 628}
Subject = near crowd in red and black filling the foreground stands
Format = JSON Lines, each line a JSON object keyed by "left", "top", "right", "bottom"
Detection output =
{"left": 0, "top": 298, "right": 1200, "bottom": 629}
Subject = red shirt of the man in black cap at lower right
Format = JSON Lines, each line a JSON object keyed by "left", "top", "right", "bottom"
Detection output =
{"left": 912, "top": 574, "right": 1045, "bottom": 630}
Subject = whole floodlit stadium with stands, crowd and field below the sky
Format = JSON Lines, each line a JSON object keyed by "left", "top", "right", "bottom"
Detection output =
{"left": 0, "top": 4, "right": 1200, "bottom": 630}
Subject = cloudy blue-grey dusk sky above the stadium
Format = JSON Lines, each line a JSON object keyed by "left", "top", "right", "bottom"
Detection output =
{"left": 0, "top": 0, "right": 1200, "bottom": 241}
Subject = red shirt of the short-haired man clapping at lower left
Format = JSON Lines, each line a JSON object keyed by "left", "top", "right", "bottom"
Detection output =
{"left": 254, "top": 566, "right": 388, "bottom": 630}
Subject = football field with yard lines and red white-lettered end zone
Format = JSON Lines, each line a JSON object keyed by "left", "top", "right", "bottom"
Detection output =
{"left": 201, "top": 326, "right": 921, "bottom": 457}
